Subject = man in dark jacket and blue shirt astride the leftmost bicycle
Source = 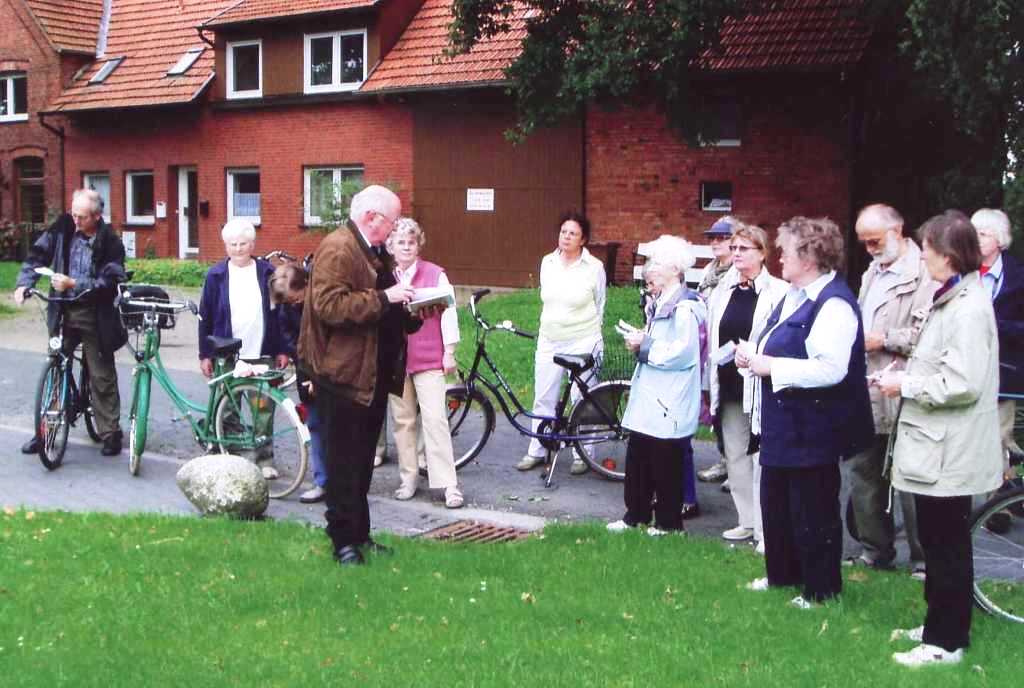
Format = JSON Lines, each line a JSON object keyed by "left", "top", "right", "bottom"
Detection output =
{"left": 14, "top": 188, "right": 128, "bottom": 457}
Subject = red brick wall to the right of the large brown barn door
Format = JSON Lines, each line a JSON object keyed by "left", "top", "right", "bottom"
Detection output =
{"left": 586, "top": 77, "right": 850, "bottom": 281}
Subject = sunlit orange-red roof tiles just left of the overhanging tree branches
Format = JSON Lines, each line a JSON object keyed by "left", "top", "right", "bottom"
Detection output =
{"left": 359, "top": 0, "right": 526, "bottom": 91}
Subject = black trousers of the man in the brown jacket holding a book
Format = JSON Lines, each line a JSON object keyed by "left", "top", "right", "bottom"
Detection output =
{"left": 315, "top": 387, "right": 387, "bottom": 552}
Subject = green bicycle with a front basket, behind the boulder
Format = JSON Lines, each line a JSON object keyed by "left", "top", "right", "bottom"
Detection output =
{"left": 118, "top": 285, "right": 309, "bottom": 499}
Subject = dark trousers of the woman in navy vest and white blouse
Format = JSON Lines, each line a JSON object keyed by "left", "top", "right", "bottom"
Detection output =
{"left": 761, "top": 464, "right": 843, "bottom": 602}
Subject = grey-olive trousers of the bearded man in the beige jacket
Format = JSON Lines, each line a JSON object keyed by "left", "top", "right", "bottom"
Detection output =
{"left": 849, "top": 435, "right": 925, "bottom": 565}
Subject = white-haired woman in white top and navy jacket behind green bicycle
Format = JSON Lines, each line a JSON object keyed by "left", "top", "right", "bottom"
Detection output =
{"left": 199, "top": 218, "right": 288, "bottom": 480}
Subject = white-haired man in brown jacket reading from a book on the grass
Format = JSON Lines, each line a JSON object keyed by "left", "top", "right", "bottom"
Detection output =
{"left": 298, "top": 185, "right": 420, "bottom": 565}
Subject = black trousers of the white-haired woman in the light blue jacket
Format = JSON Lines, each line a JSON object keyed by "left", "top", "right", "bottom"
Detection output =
{"left": 623, "top": 432, "right": 693, "bottom": 530}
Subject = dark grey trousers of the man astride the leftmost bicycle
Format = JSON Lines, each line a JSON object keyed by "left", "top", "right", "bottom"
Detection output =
{"left": 65, "top": 304, "right": 121, "bottom": 437}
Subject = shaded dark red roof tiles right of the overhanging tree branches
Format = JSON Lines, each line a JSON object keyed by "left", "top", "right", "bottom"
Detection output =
{"left": 701, "top": 0, "right": 871, "bottom": 72}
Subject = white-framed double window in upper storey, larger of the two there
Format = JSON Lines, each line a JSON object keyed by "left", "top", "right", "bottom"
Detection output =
{"left": 303, "top": 29, "right": 367, "bottom": 93}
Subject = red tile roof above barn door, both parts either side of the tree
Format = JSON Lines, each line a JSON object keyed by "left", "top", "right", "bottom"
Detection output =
{"left": 360, "top": 0, "right": 871, "bottom": 91}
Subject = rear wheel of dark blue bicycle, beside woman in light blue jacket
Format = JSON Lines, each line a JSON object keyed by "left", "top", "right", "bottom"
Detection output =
{"left": 568, "top": 380, "right": 630, "bottom": 480}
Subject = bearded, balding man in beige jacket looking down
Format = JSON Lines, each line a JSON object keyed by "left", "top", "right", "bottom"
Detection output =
{"left": 849, "top": 204, "right": 938, "bottom": 576}
